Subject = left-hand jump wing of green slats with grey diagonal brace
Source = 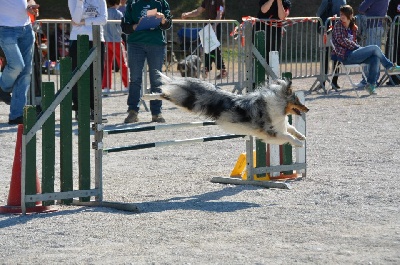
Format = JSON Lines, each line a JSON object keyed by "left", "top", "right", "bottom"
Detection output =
{"left": 9, "top": 26, "right": 137, "bottom": 214}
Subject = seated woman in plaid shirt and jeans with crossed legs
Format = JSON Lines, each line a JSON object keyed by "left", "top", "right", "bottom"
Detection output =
{"left": 332, "top": 5, "right": 400, "bottom": 95}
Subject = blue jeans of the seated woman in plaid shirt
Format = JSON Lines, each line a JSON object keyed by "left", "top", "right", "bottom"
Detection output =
{"left": 343, "top": 45, "right": 393, "bottom": 85}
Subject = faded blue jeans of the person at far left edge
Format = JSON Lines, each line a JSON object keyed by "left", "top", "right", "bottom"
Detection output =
{"left": 0, "top": 24, "right": 34, "bottom": 120}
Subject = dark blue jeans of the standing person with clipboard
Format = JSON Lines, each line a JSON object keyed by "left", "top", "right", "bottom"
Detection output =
{"left": 127, "top": 43, "right": 166, "bottom": 115}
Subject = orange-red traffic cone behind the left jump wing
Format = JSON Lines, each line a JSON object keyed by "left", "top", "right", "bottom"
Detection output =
{"left": 0, "top": 124, "right": 51, "bottom": 213}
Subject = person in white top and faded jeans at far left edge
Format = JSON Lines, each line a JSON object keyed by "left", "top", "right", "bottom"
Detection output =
{"left": 0, "top": 0, "right": 38, "bottom": 125}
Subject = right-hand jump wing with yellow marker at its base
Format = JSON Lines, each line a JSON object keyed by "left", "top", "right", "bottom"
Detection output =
{"left": 211, "top": 21, "right": 307, "bottom": 189}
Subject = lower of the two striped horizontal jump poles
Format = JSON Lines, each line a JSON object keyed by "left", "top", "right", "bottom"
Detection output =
{"left": 104, "top": 134, "right": 245, "bottom": 153}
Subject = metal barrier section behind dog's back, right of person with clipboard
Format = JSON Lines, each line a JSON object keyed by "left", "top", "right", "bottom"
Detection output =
{"left": 165, "top": 19, "right": 243, "bottom": 89}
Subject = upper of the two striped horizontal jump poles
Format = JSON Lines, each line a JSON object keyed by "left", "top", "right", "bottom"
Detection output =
{"left": 103, "top": 121, "right": 216, "bottom": 136}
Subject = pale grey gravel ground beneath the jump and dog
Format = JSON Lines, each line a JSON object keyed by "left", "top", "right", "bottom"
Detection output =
{"left": 0, "top": 75, "right": 400, "bottom": 264}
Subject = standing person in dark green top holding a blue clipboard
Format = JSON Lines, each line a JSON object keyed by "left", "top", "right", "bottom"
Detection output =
{"left": 121, "top": 0, "right": 172, "bottom": 123}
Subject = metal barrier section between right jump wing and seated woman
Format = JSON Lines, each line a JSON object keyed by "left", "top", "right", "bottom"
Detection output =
{"left": 251, "top": 17, "right": 322, "bottom": 94}
